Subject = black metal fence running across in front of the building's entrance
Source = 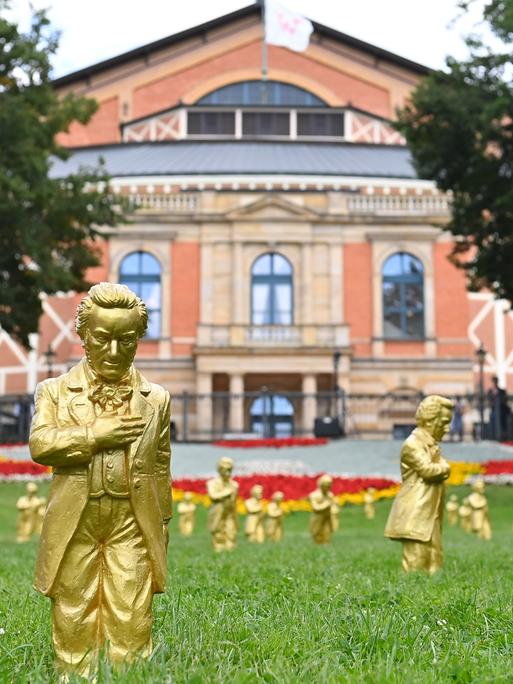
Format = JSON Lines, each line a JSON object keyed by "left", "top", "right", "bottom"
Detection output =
{"left": 0, "top": 389, "right": 513, "bottom": 444}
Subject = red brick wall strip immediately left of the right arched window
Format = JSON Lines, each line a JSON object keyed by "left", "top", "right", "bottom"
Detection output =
{"left": 344, "top": 242, "right": 372, "bottom": 356}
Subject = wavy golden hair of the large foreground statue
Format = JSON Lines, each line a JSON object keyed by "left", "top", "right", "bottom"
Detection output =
{"left": 75, "top": 283, "right": 148, "bottom": 339}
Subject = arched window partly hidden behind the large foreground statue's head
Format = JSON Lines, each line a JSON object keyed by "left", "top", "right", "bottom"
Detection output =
{"left": 119, "top": 252, "right": 162, "bottom": 337}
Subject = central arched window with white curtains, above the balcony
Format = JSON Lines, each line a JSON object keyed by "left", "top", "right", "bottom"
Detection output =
{"left": 251, "top": 253, "right": 293, "bottom": 325}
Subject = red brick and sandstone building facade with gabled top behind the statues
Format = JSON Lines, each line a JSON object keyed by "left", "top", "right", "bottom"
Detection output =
{"left": 0, "top": 5, "right": 513, "bottom": 434}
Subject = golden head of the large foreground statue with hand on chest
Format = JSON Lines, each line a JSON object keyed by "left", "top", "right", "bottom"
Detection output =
{"left": 76, "top": 283, "right": 148, "bottom": 383}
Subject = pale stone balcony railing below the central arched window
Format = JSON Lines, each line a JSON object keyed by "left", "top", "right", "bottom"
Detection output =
{"left": 198, "top": 324, "right": 349, "bottom": 348}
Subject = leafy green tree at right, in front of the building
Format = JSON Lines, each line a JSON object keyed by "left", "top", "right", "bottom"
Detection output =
{"left": 397, "top": 0, "right": 513, "bottom": 301}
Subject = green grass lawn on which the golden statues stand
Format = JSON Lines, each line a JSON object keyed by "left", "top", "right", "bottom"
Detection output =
{"left": 0, "top": 484, "right": 513, "bottom": 684}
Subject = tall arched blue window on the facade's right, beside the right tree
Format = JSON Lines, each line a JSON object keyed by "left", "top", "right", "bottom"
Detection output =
{"left": 382, "top": 252, "right": 424, "bottom": 339}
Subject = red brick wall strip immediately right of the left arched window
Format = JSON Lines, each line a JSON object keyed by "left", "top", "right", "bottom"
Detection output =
{"left": 171, "top": 242, "right": 200, "bottom": 356}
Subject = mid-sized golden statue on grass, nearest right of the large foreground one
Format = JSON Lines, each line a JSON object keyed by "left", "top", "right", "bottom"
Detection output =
{"left": 207, "top": 456, "right": 239, "bottom": 551}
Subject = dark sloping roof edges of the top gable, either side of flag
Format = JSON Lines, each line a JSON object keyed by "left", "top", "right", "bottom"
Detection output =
{"left": 53, "top": 0, "right": 431, "bottom": 87}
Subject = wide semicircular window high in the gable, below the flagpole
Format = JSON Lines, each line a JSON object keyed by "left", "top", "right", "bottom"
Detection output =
{"left": 196, "top": 81, "right": 326, "bottom": 107}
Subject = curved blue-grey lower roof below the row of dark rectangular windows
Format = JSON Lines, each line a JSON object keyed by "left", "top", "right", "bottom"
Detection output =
{"left": 51, "top": 141, "right": 416, "bottom": 179}
